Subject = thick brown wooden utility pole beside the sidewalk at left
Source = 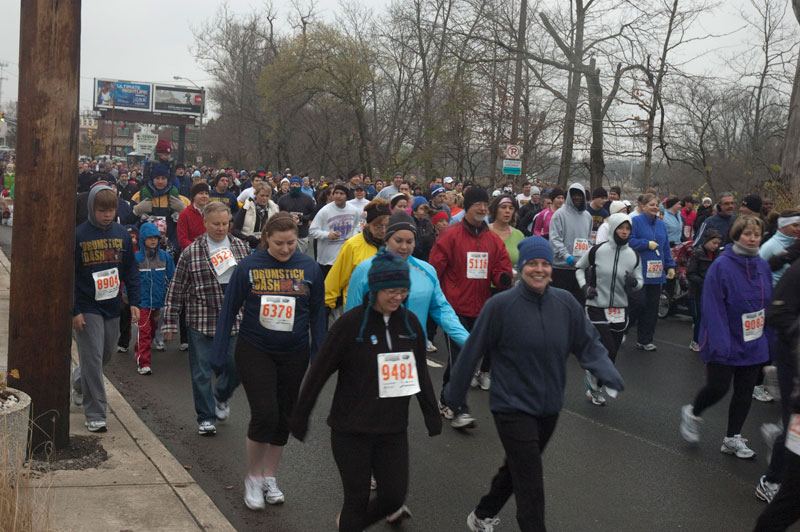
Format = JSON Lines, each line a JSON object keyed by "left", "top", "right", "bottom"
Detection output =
{"left": 8, "top": 0, "right": 81, "bottom": 448}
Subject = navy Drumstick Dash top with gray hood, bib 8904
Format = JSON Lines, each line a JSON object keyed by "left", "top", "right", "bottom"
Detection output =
{"left": 72, "top": 185, "right": 140, "bottom": 318}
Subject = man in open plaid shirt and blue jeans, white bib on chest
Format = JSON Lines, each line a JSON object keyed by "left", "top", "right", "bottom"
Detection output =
{"left": 162, "top": 202, "right": 249, "bottom": 436}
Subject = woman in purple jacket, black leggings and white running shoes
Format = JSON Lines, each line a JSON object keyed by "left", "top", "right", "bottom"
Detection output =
{"left": 680, "top": 216, "right": 772, "bottom": 458}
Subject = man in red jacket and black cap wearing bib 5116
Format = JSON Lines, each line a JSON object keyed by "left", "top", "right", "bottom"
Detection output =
{"left": 428, "top": 186, "right": 512, "bottom": 428}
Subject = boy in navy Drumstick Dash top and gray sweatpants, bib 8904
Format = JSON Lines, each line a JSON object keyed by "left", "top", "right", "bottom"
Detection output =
{"left": 72, "top": 185, "right": 140, "bottom": 432}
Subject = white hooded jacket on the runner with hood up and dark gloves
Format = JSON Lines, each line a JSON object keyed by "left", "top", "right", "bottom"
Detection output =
{"left": 575, "top": 213, "right": 644, "bottom": 308}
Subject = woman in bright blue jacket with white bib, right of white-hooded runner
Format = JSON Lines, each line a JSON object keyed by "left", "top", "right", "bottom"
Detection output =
{"left": 630, "top": 194, "right": 675, "bottom": 351}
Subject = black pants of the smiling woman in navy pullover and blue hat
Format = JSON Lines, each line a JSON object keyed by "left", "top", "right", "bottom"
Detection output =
{"left": 472, "top": 412, "right": 558, "bottom": 532}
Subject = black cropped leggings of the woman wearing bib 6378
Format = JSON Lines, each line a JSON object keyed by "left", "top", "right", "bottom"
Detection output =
{"left": 235, "top": 337, "right": 308, "bottom": 446}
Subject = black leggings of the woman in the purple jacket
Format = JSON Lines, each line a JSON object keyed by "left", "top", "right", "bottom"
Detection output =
{"left": 694, "top": 363, "right": 761, "bottom": 438}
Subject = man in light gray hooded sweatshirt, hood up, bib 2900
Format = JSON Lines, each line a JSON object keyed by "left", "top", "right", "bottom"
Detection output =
{"left": 550, "top": 183, "right": 592, "bottom": 303}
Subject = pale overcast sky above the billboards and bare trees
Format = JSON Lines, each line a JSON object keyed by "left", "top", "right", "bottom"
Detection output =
{"left": 0, "top": 0, "right": 793, "bottom": 116}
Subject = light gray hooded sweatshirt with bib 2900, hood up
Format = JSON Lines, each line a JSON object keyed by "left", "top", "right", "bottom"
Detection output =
{"left": 550, "top": 183, "right": 592, "bottom": 268}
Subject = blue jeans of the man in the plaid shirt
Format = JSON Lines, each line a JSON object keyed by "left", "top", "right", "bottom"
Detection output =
{"left": 187, "top": 327, "right": 239, "bottom": 423}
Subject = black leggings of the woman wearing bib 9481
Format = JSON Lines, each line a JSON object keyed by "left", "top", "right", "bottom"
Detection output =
{"left": 331, "top": 430, "right": 408, "bottom": 532}
